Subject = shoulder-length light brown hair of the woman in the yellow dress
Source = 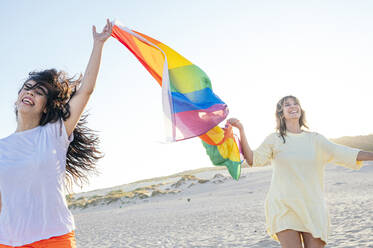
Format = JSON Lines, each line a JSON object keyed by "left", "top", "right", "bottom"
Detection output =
{"left": 276, "top": 95, "right": 308, "bottom": 143}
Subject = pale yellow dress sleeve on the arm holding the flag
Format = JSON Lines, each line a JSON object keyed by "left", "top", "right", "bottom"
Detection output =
{"left": 253, "top": 134, "right": 274, "bottom": 166}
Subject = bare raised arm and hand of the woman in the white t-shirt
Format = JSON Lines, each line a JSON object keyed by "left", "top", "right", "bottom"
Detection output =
{"left": 65, "top": 19, "right": 112, "bottom": 136}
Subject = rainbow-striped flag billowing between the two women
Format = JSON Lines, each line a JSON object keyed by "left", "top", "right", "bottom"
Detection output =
{"left": 111, "top": 23, "right": 242, "bottom": 180}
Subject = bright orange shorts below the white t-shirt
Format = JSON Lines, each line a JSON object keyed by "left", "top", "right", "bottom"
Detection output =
{"left": 0, "top": 231, "right": 76, "bottom": 248}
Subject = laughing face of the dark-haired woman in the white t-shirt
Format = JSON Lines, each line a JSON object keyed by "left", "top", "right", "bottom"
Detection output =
{"left": 16, "top": 80, "right": 48, "bottom": 119}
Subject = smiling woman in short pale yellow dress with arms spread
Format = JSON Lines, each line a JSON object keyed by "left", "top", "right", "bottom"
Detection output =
{"left": 228, "top": 96, "right": 373, "bottom": 248}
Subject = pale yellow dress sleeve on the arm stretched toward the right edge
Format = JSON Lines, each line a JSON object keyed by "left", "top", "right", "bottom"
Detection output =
{"left": 317, "top": 134, "right": 363, "bottom": 170}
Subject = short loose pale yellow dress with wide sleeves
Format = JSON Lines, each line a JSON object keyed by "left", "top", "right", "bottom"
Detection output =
{"left": 253, "top": 131, "right": 362, "bottom": 243}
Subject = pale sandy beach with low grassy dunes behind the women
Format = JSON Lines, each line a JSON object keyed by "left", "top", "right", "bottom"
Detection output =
{"left": 70, "top": 162, "right": 373, "bottom": 248}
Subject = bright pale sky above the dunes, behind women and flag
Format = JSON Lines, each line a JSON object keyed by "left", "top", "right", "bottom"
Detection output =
{"left": 0, "top": 0, "right": 373, "bottom": 191}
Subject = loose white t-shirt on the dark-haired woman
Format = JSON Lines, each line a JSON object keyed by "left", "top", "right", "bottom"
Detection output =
{"left": 0, "top": 120, "right": 75, "bottom": 246}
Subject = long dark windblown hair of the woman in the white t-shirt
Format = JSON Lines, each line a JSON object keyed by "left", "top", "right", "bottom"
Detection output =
{"left": 16, "top": 69, "right": 103, "bottom": 189}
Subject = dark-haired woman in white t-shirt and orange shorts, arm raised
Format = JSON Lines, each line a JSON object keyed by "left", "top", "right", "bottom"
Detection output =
{"left": 0, "top": 20, "right": 112, "bottom": 248}
